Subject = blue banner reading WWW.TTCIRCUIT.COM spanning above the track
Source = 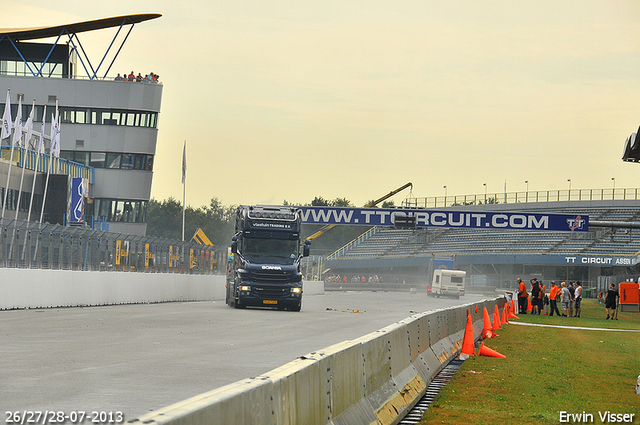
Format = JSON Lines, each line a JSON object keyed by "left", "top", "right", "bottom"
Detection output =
{"left": 299, "top": 207, "right": 589, "bottom": 232}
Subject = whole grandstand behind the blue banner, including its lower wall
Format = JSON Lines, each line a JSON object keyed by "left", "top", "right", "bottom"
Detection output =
{"left": 325, "top": 189, "right": 640, "bottom": 288}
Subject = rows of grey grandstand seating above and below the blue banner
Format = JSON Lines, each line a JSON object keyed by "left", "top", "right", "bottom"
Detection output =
{"left": 329, "top": 203, "right": 640, "bottom": 259}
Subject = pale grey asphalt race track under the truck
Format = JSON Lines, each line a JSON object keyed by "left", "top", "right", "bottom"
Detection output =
{"left": 0, "top": 291, "right": 485, "bottom": 420}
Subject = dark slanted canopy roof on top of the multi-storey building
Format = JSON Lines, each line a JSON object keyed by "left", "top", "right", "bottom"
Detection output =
{"left": 0, "top": 13, "right": 162, "bottom": 40}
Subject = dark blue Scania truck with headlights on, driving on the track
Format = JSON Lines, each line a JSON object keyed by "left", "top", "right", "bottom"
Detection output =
{"left": 226, "top": 205, "right": 311, "bottom": 311}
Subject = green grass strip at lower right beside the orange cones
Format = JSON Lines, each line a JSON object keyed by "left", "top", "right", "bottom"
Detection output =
{"left": 422, "top": 300, "right": 640, "bottom": 425}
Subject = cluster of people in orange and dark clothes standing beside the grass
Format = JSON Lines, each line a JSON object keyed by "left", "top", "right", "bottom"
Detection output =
{"left": 518, "top": 278, "right": 584, "bottom": 318}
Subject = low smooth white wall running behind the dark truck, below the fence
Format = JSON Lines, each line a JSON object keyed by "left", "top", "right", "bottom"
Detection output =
{"left": 0, "top": 268, "right": 324, "bottom": 310}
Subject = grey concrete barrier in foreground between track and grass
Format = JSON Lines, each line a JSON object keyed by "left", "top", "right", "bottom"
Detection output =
{"left": 129, "top": 297, "right": 505, "bottom": 425}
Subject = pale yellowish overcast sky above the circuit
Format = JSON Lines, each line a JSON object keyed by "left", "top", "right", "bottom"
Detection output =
{"left": 5, "top": 0, "right": 640, "bottom": 207}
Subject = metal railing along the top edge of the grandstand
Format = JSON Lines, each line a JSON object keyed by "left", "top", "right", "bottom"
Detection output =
{"left": 402, "top": 188, "right": 640, "bottom": 208}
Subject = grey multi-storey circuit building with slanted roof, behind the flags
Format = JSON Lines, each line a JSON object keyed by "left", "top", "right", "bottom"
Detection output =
{"left": 0, "top": 14, "right": 162, "bottom": 235}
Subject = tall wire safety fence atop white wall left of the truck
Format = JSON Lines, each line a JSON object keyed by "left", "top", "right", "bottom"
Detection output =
{"left": 0, "top": 220, "right": 227, "bottom": 274}
